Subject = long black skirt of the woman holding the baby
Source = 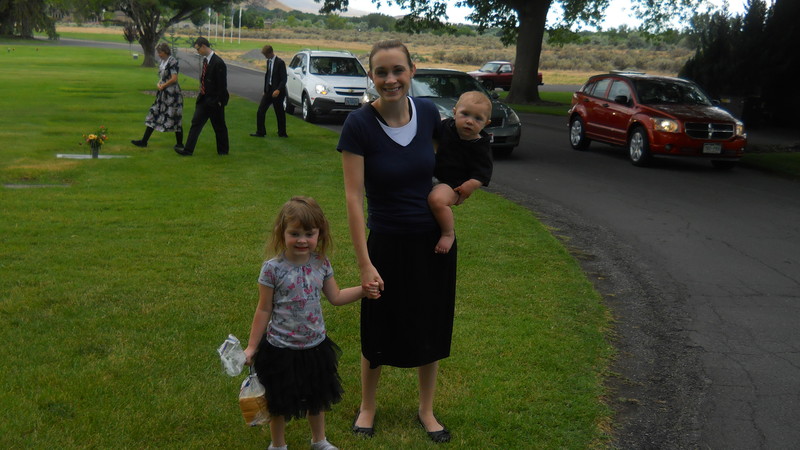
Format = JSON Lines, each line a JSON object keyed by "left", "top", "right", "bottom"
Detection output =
{"left": 361, "top": 230, "right": 458, "bottom": 368}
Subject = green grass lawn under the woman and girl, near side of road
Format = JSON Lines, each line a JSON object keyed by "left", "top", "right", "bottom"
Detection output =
{"left": 0, "top": 42, "right": 613, "bottom": 449}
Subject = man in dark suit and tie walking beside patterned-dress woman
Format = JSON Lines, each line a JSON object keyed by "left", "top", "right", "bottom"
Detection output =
{"left": 175, "top": 37, "right": 229, "bottom": 156}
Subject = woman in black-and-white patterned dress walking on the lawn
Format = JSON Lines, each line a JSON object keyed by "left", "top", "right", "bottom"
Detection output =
{"left": 131, "top": 42, "right": 183, "bottom": 149}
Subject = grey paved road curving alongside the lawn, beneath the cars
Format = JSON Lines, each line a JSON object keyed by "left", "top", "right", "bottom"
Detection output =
{"left": 59, "top": 39, "right": 800, "bottom": 449}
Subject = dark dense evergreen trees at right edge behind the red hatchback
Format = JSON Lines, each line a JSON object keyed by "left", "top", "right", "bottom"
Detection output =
{"left": 679, "top": 0, "right": 800, "bottom": 126}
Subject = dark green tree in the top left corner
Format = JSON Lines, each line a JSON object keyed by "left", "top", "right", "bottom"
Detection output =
{"left": 0, "top": 0, "right": 58, "bottom": 39}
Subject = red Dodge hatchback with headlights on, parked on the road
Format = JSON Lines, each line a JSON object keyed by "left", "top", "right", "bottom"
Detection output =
{"left": 569, "top": 72, "right": 747, "bottom": 169}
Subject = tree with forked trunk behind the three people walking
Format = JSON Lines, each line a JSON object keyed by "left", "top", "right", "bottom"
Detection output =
{"left": 79, "top": 0, "right": 230, "bottom": 67}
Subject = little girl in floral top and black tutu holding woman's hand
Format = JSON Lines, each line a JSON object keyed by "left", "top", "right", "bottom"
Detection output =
{"left": 245, "top": 197, "right": 379, "bottom": 450}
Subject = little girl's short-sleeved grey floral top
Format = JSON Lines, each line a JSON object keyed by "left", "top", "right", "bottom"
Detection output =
{"left": 258, "top": 253, "right": 333, "bottom": 349}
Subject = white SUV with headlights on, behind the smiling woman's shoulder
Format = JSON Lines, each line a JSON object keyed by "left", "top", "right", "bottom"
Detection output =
{"left": 286, "top": 50, "right": 369, "bottom": 122}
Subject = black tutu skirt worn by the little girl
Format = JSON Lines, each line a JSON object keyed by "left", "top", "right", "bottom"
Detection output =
{"left": 253, "top": 337, "right": 344, "bottom": 421}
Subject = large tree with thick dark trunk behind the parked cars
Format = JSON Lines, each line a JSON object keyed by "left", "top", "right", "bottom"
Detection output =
{"left": 314, "top": 0, "right": 705, "bottom": 103}
